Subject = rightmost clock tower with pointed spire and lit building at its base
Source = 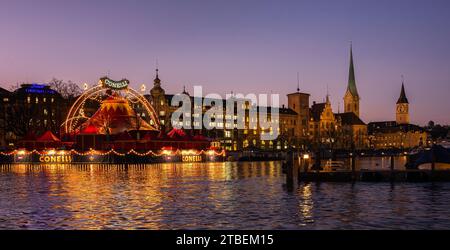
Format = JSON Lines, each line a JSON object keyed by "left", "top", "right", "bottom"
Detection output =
{"left": 369, "top": 82, "right": 428, "bottom": 149}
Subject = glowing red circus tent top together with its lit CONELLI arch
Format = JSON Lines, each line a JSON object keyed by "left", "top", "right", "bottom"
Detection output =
{"left": 61, "top": 77, "right": 160, "bottom": 138}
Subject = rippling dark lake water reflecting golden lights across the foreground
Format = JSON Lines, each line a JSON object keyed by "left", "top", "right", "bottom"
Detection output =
{"left": 0, "top": 160, "right": 450, "bottom": 229}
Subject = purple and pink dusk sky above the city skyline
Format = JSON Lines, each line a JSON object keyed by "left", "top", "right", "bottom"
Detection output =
{"left": 0, "top": 0, "right": 450, "bottom": 125}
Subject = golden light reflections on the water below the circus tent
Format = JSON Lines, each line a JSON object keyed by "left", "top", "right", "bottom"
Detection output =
{"left": 0, "top": 162, "right": 281, "bottom": 229}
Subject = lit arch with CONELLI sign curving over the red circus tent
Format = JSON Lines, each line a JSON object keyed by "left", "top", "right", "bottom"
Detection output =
{"left": 61, "top": 77, "right": 160, "bottom": 135}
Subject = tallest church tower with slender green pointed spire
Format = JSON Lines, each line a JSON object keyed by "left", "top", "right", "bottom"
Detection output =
{"left": 344, "top": 45, "right": 359, "bottom": 117}
